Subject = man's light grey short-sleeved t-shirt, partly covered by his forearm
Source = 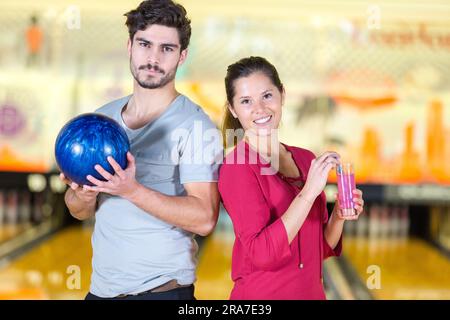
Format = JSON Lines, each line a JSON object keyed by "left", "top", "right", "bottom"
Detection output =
{"left": 90, "top": 95, "right": 222, "bottom": 297}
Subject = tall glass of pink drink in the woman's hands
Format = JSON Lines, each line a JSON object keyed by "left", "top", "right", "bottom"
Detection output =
{"left": 336, "top": 163, "right": 356, "bottom": 216}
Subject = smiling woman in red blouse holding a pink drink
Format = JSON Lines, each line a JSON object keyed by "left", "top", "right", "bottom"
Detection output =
{"left": 219, "top": 57, "right": 364, "bottom": 299}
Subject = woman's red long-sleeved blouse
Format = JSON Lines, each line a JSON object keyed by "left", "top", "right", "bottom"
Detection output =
{"left": 219, "top": 141, "right": 342, "bottom": 300}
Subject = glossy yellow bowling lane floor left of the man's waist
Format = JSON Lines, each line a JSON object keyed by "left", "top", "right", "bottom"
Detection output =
{"left": 0, "top": 226, "right": 92, "bottom": 300}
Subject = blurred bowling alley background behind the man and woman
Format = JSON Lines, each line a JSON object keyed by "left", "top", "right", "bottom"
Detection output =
{"left": 0, "top": 0, "right": 450, "bottom": 299}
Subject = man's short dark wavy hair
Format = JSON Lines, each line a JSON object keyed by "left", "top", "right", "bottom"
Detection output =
{"left": 125, "top": 0, "right": 191, "bottom": 50}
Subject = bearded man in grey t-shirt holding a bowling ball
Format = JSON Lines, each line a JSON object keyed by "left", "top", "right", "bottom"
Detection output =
{"left": 61, "top": 0, "right": 222, "bottom": 300}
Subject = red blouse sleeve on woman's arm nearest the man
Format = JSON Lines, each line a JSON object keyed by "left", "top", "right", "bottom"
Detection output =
{"left": 219, "top": 164, "right": 292, "bottom": 271}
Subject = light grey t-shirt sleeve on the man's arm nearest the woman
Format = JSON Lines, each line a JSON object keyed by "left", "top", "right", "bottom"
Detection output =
{"left": 179, "top": 116, "right": 223, "bottom": 184}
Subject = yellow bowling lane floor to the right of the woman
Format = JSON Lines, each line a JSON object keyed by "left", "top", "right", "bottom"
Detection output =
{"left": 344, "top": 237, "right": 450, "bottom": 299}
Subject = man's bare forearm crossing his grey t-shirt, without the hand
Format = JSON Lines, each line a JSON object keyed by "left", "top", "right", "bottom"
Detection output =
{"left": 127, "top": 184, "right": 218, "bottom": 236}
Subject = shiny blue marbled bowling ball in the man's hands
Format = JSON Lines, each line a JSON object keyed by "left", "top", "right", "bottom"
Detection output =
{"left": 55, "top": 113, "right": 130, "bottom": 185}
